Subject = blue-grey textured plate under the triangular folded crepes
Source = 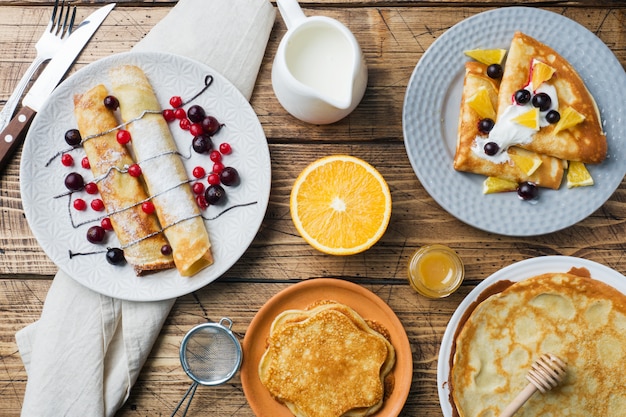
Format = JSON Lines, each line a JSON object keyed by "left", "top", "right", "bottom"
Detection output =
{"left": 402, "top": 7, "right": 626, "bottom": 236}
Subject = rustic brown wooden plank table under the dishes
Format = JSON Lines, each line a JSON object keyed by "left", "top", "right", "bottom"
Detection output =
{"left": 0, "top": 0, "right": 626, "bottom": 416}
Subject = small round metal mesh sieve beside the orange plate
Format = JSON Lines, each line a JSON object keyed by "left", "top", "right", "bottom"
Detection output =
{"left": 171, "top": 318, "right": 242, "bottom": 417}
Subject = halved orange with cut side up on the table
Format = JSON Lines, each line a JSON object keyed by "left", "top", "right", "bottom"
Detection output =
{"left": 289, "top": 155, "right": 391, "bottom": 255}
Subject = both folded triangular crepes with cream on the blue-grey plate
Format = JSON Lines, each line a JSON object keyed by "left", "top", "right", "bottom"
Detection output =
{"left": 454, "top": 32, "right": 607, "bottom": 189}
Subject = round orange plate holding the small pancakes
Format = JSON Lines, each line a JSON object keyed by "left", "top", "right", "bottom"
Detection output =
{"left": 241, "top": 278, "right": 413, "bottom": 417}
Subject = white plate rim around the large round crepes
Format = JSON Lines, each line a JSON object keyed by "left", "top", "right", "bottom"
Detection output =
{"left": 437, "top": 256, "right": 626, "bottom": 417}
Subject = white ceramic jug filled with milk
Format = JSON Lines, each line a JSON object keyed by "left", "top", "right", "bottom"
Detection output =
{"left": 272, "top": 0, "right": 367, "bottom": 124}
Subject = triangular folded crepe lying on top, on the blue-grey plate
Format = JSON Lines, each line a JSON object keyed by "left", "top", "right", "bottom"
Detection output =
{"left": 496, "top": 32, "right": 607, "bottom": 164}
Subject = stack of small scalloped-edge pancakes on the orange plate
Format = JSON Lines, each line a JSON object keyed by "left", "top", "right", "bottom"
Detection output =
{"left": 259, "top": 301, "right": 396, "bottom": 417}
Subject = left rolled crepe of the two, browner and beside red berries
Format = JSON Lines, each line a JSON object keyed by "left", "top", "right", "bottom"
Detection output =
{"left": 74, "top": 85, "right": 174, "bottom": 275}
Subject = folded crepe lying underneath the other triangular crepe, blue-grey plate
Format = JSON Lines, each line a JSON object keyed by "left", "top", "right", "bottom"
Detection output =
{"left": 454, "top": 62, "right": 563, "bottom": 189}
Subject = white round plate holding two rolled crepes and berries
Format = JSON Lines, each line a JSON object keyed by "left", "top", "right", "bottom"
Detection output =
{"left": 20, "top": 52, "right": 271, "bottom": 301}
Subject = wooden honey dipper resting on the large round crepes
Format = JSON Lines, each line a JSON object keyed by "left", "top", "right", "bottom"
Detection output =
{"left": 500, "top": 353, "right": 566, "bottom": 417}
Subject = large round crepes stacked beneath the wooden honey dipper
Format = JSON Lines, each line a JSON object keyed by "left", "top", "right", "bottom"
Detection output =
{"left": 450, "top": 270, "right": 626, "bottom": 417}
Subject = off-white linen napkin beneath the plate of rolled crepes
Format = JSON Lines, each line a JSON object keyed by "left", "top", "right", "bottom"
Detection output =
{"left": 16, "top": 0, "right": 276, "bottom": 417}
